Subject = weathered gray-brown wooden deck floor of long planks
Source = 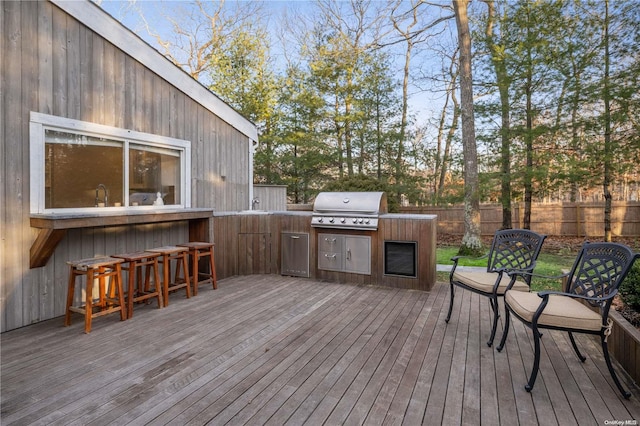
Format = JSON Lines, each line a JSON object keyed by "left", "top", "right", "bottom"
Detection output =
{"left": 0, "top": 275, "right": 640, "bottom": 425}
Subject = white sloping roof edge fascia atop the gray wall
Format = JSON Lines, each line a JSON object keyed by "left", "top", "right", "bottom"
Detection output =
{"left": 50, "top": 0, "right": 258, "bottom": 141}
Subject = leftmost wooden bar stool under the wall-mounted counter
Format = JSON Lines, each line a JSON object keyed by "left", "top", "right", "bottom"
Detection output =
{"left": 64, "top": 256, "right": 127, "bottom": 333}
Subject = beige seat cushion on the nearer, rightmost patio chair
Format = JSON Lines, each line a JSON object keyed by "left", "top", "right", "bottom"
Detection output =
{"left": 504, "top": 291, "right": 602, "bottom": 331}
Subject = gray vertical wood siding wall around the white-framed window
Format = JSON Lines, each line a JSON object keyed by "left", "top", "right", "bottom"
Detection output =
{"left": 0, "top": 1, "right": 250, "bottom": 331}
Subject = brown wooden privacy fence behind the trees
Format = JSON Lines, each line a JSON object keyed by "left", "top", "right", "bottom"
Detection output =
{"left": 401, "top": 201, "right": 640, "bottom": 237}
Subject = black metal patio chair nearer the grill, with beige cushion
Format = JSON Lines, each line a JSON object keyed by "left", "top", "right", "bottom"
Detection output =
{"left": 445, "top": 229, "right": 546, "bottom": 346}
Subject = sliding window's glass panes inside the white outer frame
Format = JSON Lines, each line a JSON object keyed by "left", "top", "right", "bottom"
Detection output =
{"left": 44, "top": 129, "right": 182, "bottom": 209}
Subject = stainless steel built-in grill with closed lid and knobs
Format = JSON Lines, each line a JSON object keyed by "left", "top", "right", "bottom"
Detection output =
{"left": 311, "top": 192, "right": 387, "bottom": 230}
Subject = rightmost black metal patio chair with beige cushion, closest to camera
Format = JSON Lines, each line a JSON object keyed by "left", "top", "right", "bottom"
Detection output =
{"left": 496, "top": 243, "right": 640, "bottom": 399}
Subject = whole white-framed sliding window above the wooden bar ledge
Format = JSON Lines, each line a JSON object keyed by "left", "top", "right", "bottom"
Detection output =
{"left": 30, "top": 112, "right": 191, "bottom": 213}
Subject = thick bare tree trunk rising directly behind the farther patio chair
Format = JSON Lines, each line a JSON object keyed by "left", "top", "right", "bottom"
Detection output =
{"left": 453, "top": 0, "right": 482, "bottom": 254}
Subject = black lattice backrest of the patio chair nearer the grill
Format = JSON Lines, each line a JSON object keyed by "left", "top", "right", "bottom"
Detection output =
{"left": 487, "top": 229, "right": 547, "bottom": 283}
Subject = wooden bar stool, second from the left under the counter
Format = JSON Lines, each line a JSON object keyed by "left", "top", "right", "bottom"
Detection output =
{"left": 111, "top": 251, "right": 164, "bottom": 318}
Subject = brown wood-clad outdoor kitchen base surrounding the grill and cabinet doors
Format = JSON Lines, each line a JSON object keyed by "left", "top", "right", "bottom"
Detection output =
{"left": 213, "top": 211, "right": 437, "bottom": 291}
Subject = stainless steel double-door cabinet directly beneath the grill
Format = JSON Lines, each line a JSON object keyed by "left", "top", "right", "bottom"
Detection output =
{"left": 318, "top": 234, "right": 371, "bottom": 275}
